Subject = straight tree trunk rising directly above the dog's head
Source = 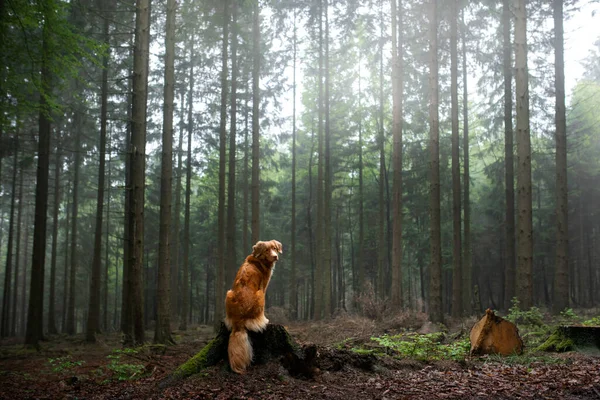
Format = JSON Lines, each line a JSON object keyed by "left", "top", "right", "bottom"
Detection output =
{"left": 252, "top": 0, "right": 260, "bottom": 243}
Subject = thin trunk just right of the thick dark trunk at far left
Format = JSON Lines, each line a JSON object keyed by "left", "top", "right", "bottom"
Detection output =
{"left": 48, "top": 131, "right": 62, "bottom": 335}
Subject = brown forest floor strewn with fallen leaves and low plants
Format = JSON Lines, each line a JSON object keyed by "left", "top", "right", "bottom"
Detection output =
{"left": 0, "top": 310, "right": 600, "bottom": 400}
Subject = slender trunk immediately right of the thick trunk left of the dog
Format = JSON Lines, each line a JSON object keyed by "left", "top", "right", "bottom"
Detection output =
{"left": 179, "top": 38, "right": 193, "bottom": 330}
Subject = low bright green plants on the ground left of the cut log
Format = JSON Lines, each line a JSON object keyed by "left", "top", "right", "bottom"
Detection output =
{"left": 371, "top": 333, "right": 471, "bottom": 361}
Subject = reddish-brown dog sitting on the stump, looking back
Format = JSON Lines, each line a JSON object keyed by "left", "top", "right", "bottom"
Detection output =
{"left": 225, "top": 240, "right": 283, "bottom": 374}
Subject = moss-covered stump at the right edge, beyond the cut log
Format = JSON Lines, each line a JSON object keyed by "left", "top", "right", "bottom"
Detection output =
{"left": 538, "top": 325, "right": 600, "bottom": 352}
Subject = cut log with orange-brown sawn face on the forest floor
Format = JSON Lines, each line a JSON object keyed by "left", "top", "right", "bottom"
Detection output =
{"left": 470, "top": 308, "right": 523, "bottom": 356}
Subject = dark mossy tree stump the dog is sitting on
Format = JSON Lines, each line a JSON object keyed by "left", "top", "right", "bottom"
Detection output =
{"left": 160, "top": 323, "right": 317, "bottom": 387}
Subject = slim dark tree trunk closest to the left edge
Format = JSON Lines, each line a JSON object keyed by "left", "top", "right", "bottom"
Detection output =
{"left": 0, "top": 139, "right": 19, "bottom": 338}
